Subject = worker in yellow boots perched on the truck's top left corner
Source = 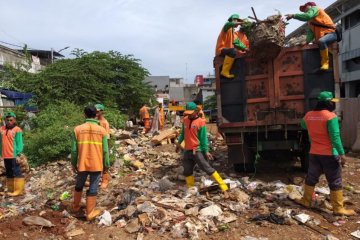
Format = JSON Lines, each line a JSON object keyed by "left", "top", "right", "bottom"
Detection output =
{"left": 215, "top": 14, "right": 248, "bottom": 78}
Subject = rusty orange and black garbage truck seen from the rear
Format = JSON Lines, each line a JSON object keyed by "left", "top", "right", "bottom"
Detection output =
{"left": 214, "top": 44, "right": 340, "bottom": 171}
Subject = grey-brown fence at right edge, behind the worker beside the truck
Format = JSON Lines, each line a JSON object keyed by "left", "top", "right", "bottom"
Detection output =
{"left": 340, "top": 98, "right": 360, "bottom": 149}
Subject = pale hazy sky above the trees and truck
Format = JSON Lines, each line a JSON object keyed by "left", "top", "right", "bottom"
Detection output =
{"left": 0, "top": 0, "right": 335, "bottom": 82}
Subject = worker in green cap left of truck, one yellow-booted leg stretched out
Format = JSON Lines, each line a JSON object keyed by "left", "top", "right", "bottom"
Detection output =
{"left": 176, "top": 102, "right": 228, "bottom": 198}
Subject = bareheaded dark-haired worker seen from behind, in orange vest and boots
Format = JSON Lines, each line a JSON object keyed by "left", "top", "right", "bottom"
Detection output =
{"left": 71, "top": 106, "right": 110, "bottom": 221}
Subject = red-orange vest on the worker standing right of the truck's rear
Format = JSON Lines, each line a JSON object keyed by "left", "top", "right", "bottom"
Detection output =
{"left": 304, "top": 110, "right": 337, "bottom": 156}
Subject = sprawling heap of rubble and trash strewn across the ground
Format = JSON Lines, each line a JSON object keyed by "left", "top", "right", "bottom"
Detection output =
{"left": 0, "top": 126, "right": 355, "bottom": 239}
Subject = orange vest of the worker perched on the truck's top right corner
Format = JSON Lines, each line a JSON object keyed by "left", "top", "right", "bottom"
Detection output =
{"left": 308, "top": 7, "right": 335, "bottom": 41}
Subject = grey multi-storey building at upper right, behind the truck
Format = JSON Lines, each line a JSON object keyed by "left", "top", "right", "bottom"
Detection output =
{"left": 286, "top": 0, "right": 360, "bottom": 98}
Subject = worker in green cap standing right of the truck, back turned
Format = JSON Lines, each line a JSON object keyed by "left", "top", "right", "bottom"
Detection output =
{"left": 296, "top": 91, "right": 355, "bottom": 216}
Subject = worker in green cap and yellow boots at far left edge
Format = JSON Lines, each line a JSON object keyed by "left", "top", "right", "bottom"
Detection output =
{"left": 0, "top": 112, "right": 25, "bottom": 197}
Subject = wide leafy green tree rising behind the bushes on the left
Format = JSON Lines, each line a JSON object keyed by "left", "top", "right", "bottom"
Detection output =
{"left": 0, "top": 49, "right": 154, "bottom": 112}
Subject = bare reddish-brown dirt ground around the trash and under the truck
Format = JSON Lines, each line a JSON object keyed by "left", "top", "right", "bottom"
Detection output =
{"left": 0, "top": 124, "right": 360, "bottom": 240}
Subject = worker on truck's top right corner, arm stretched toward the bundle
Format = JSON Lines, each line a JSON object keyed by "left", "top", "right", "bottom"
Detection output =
{"left": 285, "top": 2, "right": 338, "bottom": 71}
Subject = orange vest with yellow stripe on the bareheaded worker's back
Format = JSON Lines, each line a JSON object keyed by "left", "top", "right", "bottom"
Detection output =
{"left": 74, "top": 122, "right": 107, "bottom": 172}
